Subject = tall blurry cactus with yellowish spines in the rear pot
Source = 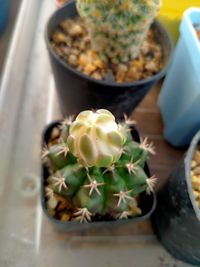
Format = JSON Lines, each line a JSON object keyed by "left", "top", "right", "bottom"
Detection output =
{"left": 77, "top": 0, "right": 161, "bottom": 64}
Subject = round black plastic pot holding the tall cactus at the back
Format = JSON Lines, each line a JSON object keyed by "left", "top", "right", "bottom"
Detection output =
{"left": 45, "top": 1, "right": 173, "bottom": 118}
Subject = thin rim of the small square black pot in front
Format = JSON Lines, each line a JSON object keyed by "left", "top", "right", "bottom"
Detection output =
{"left": 40, "top": 120, "right": 157, "bottom": 230}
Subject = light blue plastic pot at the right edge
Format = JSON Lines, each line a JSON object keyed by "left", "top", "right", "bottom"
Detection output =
{"left": 158, "top": 8, "right": 200, "bottom": 146}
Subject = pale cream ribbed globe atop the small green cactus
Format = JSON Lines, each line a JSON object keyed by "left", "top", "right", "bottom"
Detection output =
{"left": 68, "top": 109, "right": 125, "bottom": 167}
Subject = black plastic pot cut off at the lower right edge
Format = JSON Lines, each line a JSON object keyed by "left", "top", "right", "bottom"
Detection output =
{"left": 152, "top": 131, "right": 200, "bottom": 266}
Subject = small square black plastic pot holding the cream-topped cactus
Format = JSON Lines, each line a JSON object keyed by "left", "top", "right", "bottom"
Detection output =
{"left": 41, "top": 121, "right": 156, "bottom": 232}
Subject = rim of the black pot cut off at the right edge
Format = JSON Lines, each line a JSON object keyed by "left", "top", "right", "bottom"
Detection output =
{"left": 184, "top": 130, "right": 200, "bottom": 222}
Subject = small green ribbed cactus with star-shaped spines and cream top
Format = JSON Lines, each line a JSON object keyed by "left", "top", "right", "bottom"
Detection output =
{"left": 42, "top": 109, "right": 156, "bottom": 222}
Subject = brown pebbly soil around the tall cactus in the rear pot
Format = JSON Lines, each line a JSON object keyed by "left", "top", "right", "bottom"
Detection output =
{"left": 51, "top": 17, "right": 163, "bottom": 83}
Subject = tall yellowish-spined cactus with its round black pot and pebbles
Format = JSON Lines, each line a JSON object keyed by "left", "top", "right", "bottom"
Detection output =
{"left": 46, "top": 0, "right": 172, "bottom": 118}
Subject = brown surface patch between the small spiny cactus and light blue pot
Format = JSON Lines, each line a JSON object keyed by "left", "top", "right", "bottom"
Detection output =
{"left": 132, "top": 82, "right": 185, "bottom": 190}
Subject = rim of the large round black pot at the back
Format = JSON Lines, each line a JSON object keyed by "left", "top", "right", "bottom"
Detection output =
{"left": 45, "top": 0, "right": 174, "bottom": 88}
